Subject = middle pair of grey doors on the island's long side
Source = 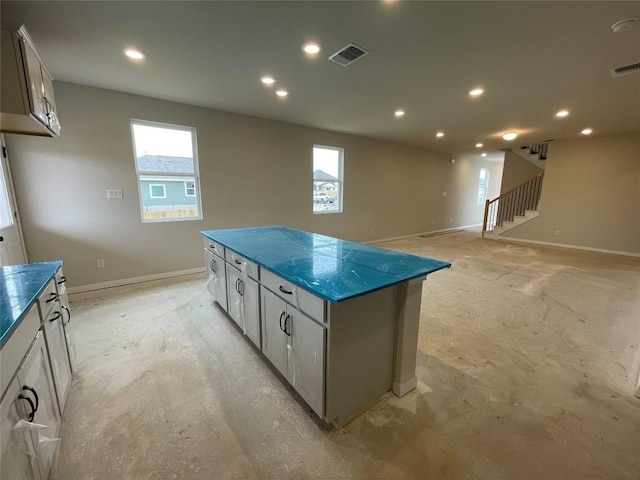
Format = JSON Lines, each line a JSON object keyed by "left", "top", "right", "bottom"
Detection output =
{"left": 227, "top": 263, "right": 260, "bottom": 348}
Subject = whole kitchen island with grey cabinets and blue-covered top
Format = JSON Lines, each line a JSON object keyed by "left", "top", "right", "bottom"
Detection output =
{"left": 201, "top": 226, "right": 451, "bottom": 426}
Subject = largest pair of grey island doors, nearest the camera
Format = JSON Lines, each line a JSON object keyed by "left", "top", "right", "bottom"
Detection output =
{"left": 261, "top": 287, "right": 326, "bottom": 418}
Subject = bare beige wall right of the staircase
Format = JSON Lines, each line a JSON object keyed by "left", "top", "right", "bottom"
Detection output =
{"left": 507, "top": 133, "right": 640, "bottom": 253}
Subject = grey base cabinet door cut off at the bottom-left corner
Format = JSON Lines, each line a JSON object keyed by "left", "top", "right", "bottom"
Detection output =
{"left": 0, "top": 377, "right": 40, "bottom": 480}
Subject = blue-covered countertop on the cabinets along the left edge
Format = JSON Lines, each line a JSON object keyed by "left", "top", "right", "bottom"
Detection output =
{"left": 0, "top": 261, "right": 63, "bottom": 346}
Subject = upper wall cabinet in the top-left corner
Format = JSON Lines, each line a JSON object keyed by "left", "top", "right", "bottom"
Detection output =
{"left": 0, "top": 25, "right": 60, "bottom": 137}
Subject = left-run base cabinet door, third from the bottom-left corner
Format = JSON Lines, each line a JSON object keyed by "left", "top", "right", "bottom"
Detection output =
{"left": 44, "top": 310, "right": 71, "bottom": 415}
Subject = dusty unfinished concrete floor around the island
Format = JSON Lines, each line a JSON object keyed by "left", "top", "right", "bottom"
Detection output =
{"left": 54, "top": 232, "right": 640, "bottom": 480}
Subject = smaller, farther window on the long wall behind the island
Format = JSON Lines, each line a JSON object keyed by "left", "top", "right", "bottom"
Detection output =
{"left": 313, "top": 145, "right": 344, "bottom": 213}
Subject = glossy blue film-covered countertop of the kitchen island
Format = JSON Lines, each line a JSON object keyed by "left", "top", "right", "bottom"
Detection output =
{"left": 200, "top": 227, "right": 451, "bottom": 303}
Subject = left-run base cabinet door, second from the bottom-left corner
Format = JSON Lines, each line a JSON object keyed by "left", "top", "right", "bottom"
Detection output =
{"left": 18, "top": 331, "right": 60, "bottom": 478}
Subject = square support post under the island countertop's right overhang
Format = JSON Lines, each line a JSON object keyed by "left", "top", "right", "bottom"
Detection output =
{"left": 393, "top": 278, "right": 424, "bottom": 397}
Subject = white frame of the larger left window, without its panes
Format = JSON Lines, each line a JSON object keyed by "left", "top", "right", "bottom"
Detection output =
{"left": 129, "top": 118, "right": 203, "bottom": 223}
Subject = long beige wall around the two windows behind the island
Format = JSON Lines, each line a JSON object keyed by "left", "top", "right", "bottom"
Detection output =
{"left": 7, "top": 82, "right": 490, "bottom": 287}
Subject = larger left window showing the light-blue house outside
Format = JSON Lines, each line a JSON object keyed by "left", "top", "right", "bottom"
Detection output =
{"left": 131, "top": 120, "right": 202, "bottom": 223}
